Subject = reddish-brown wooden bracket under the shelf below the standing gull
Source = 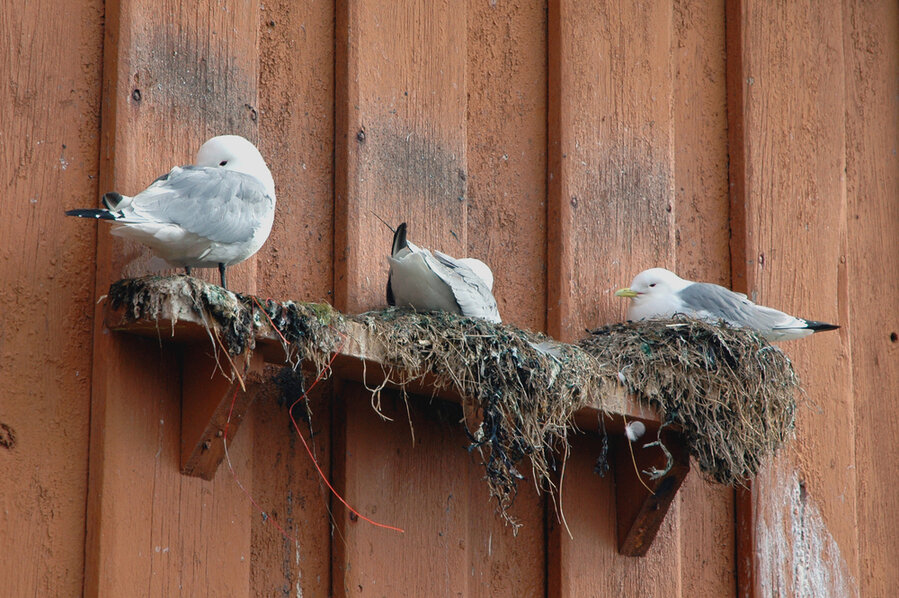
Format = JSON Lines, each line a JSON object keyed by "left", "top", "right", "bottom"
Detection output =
{"left": 181, "top": 342, "right": 264, "bottom": 480}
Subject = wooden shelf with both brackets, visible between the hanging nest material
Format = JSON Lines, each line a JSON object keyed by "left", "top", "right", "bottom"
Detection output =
{"left": 105, "top": 276, "right": 689, "bottom": 556}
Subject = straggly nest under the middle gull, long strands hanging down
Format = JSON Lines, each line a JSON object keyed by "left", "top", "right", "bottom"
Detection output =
{"left": 354, "top": 309, "right": 603, "bottom": 523}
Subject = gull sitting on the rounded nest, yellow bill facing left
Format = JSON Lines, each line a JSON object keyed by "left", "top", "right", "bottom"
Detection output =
{"left": 615, "top": 268, "right": 839, "bottom": 341}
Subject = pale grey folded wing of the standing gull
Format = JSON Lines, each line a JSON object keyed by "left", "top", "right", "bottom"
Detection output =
{"left": 120, "top": 166, "right": 274, "bottom": 243}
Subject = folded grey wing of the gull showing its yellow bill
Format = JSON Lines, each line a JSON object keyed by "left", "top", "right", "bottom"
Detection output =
{"left": 677, "top": 282, "right": 796, "bottom": 331}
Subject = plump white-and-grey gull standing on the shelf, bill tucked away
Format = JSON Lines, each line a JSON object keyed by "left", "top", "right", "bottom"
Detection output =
{"left": 66, "top": 135, "right": 275, "bottom": 288}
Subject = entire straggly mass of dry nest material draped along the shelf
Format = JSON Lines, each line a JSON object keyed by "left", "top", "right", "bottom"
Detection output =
{"left": 109, "top": 276, "right": 799, "bottom": 527}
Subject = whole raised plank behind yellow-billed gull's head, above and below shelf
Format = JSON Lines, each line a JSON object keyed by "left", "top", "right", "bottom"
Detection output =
{"left": 547, "top": 0, "right": 681, "bottom": 597}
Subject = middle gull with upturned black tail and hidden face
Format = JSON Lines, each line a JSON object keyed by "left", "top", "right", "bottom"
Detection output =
{"left": 387, "top": 222, "right": 501, "bottom": 324}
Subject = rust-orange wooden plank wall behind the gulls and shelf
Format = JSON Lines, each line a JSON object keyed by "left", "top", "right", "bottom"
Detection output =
{"left": 0, "top": 0, "right": 899, "bottom": 597}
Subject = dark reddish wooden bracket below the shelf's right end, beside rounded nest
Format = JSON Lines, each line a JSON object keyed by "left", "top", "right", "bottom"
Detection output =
{"left": 612, "top": 431, "right": 690, "bottom": 556}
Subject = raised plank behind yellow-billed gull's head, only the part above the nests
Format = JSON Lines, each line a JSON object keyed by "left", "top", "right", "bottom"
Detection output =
{"left": 547, "top": 0, "right": 674, "bottom": 341}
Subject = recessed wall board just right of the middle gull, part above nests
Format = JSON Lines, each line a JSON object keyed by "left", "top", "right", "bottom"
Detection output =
{"left": 466, "top": 0, "right": 547, "bottom": 330}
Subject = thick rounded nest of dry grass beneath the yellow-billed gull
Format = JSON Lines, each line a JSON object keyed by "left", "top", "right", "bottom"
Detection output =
{"left": 579, "top": 316, "right": 799, "bottom": 484}
